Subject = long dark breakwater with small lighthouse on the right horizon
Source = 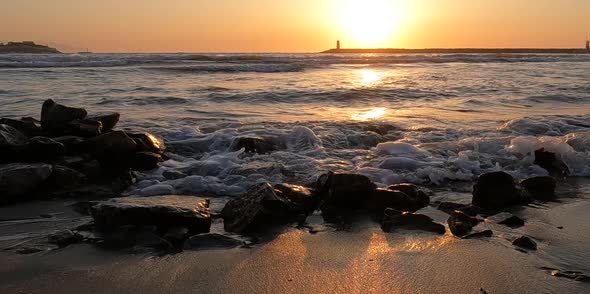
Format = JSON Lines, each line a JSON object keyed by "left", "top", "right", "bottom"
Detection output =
{"left": 321, "top": 40, "right": 590, "bottom": 54}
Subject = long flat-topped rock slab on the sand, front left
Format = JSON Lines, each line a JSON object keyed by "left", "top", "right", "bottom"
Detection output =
{"left": 90, "top": 195, "right": 211, "bottom": 234}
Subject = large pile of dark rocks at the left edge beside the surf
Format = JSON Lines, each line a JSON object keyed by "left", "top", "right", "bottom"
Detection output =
{"left": 0, "top": 99, "right": 165, "bottom": 204}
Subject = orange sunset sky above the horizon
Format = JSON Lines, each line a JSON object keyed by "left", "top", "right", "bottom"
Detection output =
{"left": 0, "top": 0, "right": 590, "bottom": 52}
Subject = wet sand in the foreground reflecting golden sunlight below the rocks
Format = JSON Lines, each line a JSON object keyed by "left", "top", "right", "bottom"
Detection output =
{"left": 0, "top": 181, "right": 590, "bottom": 293}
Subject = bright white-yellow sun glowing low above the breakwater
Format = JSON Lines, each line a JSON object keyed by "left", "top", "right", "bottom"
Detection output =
{"left": 339, "top": 0, "right": 402, "bottom": 47}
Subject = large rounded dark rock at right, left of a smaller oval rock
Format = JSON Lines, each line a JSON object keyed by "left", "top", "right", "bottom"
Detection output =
{"left": 472, "top": 172, "right": 526, "bottom": 209}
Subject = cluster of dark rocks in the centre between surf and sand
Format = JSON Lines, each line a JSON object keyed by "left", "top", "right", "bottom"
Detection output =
{"left": 221, "top": 172, "right": 445, "bottom": 233}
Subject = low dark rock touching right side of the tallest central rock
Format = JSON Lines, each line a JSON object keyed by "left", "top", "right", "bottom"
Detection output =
{"left": 366, "top": 188, "right": 428, "bottom": 215}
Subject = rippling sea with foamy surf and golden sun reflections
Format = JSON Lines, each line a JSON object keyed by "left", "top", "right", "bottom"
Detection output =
{"left": 0, "top": 53, "right": 590, "bottom": 197}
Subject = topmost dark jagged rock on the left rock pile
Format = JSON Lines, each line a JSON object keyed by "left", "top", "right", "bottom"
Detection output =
{"left": 41, "top": 99, "right": 87, "bottom": 135}
